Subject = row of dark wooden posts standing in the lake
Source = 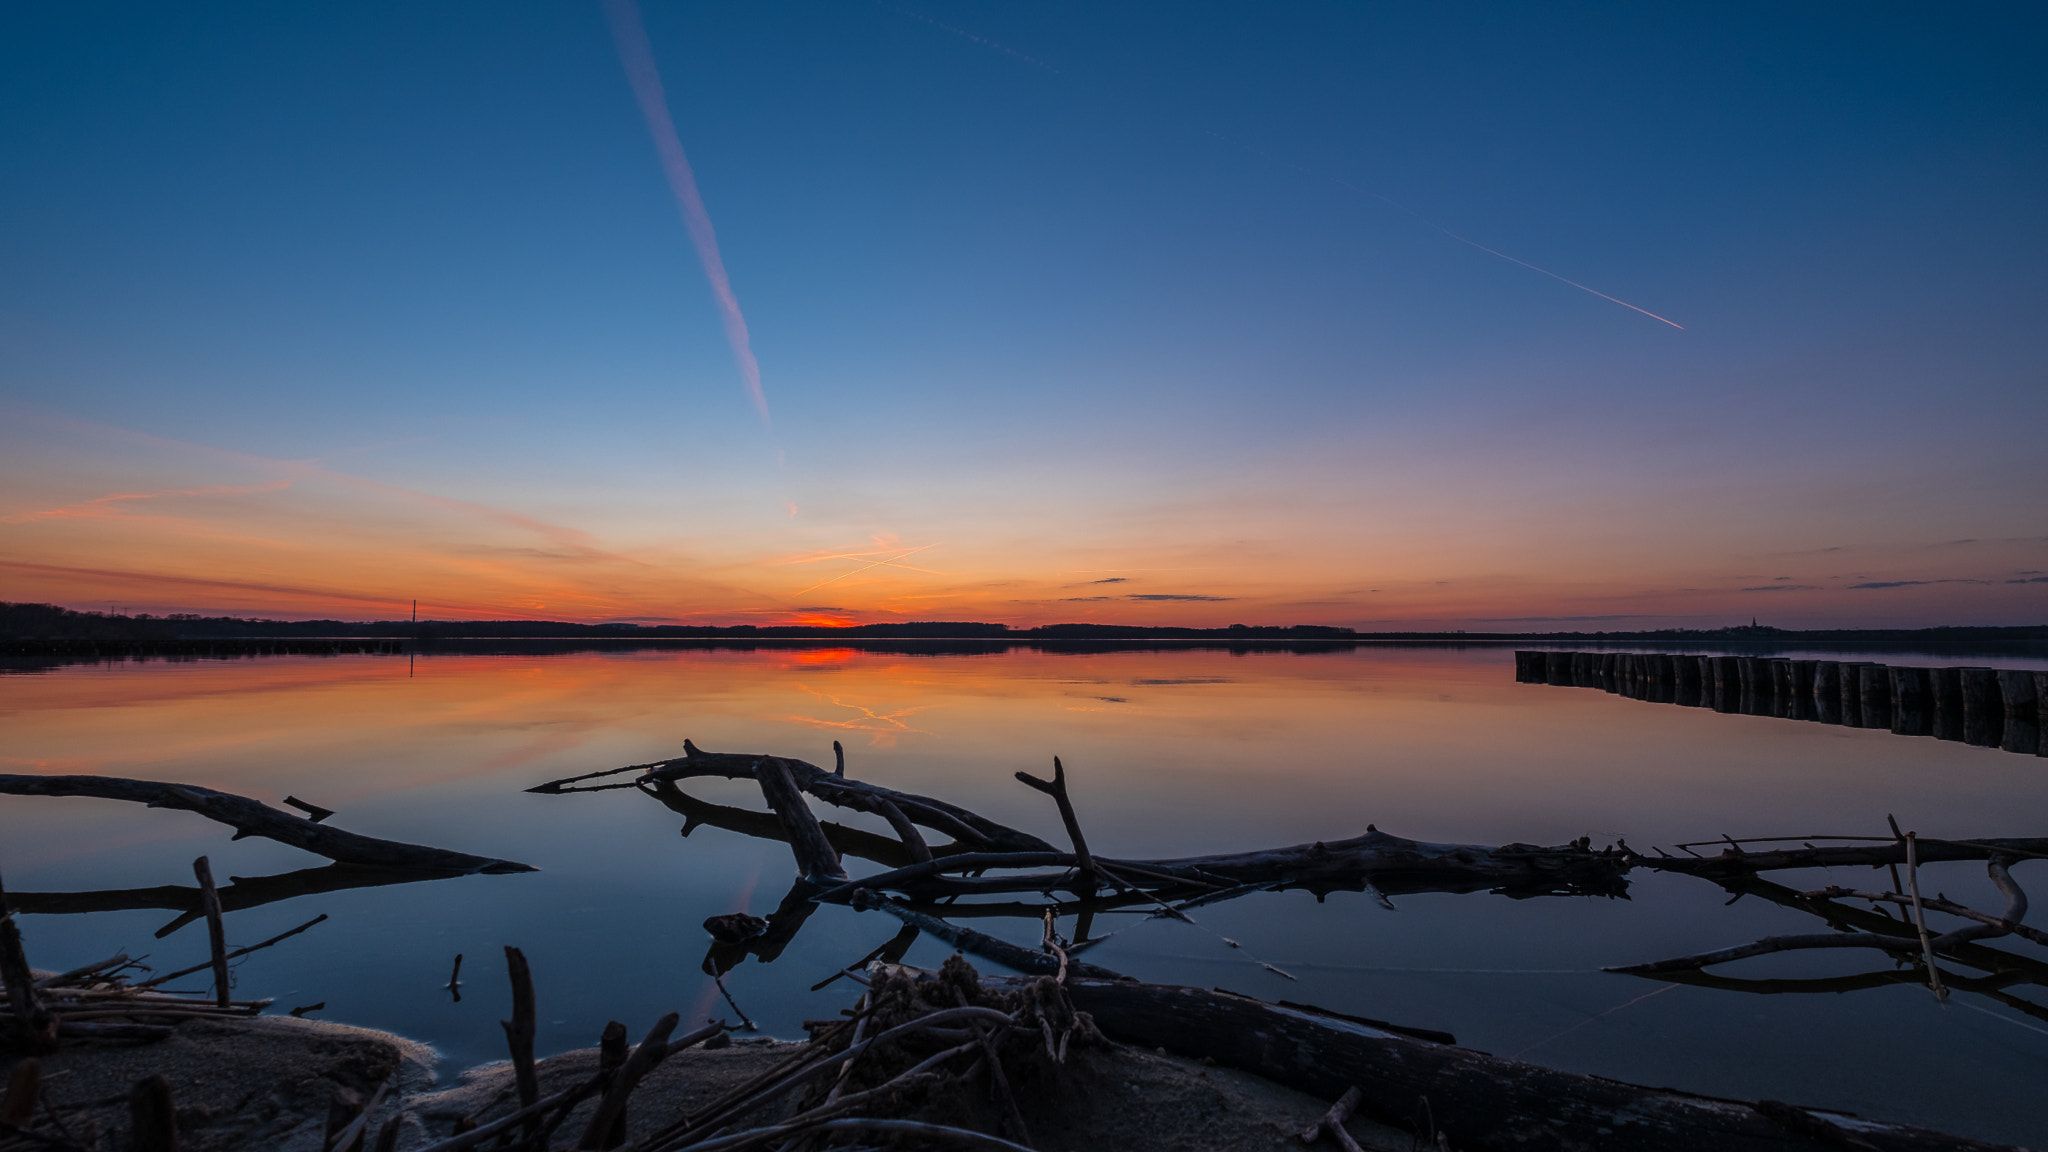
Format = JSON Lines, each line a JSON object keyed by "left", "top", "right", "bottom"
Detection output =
{"left": 1516, "top": 652, "right": 2048, "bottom": 756}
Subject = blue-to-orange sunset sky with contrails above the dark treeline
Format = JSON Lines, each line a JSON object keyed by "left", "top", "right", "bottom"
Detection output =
{"left": 0, "top": 0, "right": 2048, "bottom": 631}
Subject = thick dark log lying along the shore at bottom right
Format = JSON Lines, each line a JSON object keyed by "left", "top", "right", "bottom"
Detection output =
{"left": 985, "top": 978, "right": 2031, "bottom": 1152}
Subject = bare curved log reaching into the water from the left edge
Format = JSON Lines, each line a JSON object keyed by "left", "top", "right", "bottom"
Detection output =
{"left": 0, "top": 775, "right": 535, "bottom": 873}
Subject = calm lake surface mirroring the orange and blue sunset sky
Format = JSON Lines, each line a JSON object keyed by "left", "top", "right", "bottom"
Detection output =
{"left": 0, "top": 648, "right": 2048, "bottom": 1142}
